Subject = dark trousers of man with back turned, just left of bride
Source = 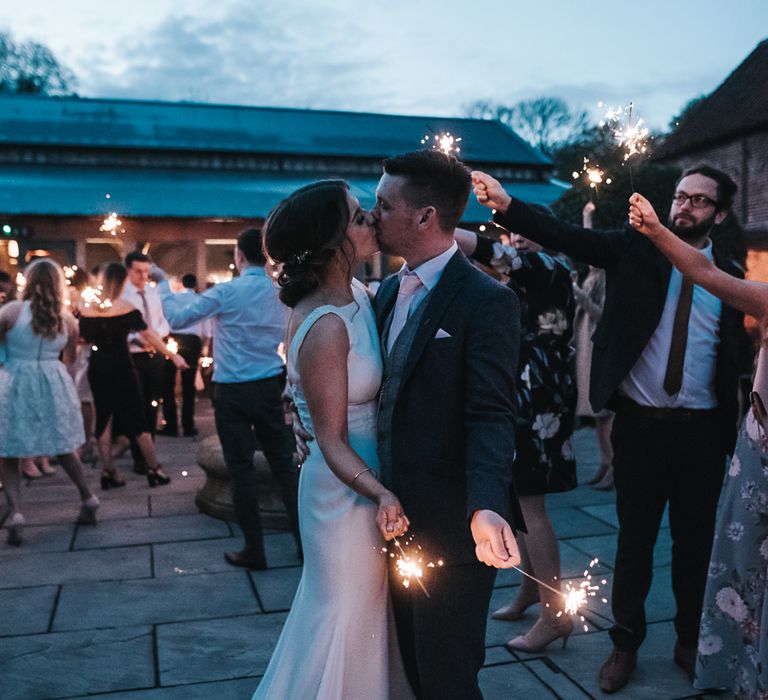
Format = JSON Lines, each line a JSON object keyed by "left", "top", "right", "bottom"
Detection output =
{"left": 213, "top": 377, "right": 299, "bottom": 555}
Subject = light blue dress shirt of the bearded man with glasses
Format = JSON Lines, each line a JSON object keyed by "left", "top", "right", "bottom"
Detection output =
{"left": 619, "top": 243, "right": 722, "bottom": 409}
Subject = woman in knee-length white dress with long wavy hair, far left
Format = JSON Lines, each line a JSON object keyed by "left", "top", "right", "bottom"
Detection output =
{"left": 0, "top": 258, "right": 99, "bottom": 546}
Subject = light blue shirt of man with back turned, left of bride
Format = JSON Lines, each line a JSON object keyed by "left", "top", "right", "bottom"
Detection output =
{"left": 159, "top": 266, "right": 288, "bottom": 384}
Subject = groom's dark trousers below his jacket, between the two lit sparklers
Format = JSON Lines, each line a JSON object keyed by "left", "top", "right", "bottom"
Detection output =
{"left": 389, "top": 562, "right": 496, "bottom": 700}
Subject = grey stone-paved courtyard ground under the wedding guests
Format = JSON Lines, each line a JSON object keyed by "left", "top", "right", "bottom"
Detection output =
{"left": 0, "top": 402, "right": 728, "bottom": 700}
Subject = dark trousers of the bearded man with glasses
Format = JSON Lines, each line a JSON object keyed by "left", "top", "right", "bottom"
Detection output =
{"left": 611, "top": 412, "right": 725, "bottom": 651}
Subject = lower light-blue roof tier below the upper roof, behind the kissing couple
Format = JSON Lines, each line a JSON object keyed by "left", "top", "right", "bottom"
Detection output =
{"left": 0, "top": 165, "right": 565, "bottom": 221}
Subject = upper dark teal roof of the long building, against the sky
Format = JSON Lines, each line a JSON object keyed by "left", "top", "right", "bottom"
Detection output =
{"left": 0, "top": 96, "right": 550, "bottom": 168}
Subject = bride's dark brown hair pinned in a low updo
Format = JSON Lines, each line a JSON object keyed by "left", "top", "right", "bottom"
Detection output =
{"left": 264, "top": 180, "right": 349, "bottom": 307}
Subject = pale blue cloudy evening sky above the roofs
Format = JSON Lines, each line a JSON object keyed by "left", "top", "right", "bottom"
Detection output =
{"left": 0, "top": 0, "right": 768, "bottom": 127}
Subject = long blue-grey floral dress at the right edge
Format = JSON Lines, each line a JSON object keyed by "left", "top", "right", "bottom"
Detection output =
{"left": 694, "top": 353, "right": 768, "bottom": 700}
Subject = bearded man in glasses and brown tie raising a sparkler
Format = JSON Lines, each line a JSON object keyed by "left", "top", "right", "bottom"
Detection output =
{"left": 473, "top": 166, "right": 748, "bottom": 693}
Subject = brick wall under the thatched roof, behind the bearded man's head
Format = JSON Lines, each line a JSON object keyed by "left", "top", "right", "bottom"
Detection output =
{"left": 670, "top": 131, "right": 768, "bottom": 242}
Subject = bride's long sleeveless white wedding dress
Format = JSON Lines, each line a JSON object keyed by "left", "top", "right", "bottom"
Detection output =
{"left": 253, "top": 284, "right": 413, "bottom": 700}
